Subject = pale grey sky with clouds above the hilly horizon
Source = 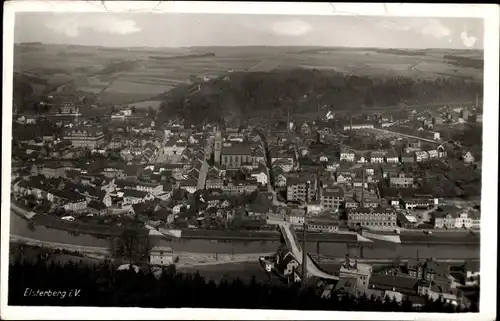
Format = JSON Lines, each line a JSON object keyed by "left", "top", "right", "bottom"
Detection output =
{"left": 14, "top": 12, "right": 483, "bottom": 49}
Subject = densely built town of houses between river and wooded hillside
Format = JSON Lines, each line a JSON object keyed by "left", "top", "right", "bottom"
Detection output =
{"left": 12, "top": 94, "right": 482, "bottom": 232}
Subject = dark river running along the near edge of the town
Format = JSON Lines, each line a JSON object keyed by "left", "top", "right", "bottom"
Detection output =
{"left": 10, "top": 213, "right": 480, "bottom": 259}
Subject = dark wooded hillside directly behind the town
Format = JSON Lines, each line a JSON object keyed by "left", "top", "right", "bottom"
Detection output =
{"left": 158, "top": 69, "right": 483, "bottom": 124}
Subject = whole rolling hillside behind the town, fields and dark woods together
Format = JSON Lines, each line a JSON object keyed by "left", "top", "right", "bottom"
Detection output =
{"left": 14, "top": 43, "right": 483, "bottom": 115}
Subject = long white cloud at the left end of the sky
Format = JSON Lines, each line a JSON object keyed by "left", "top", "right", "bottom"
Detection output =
{"left": 45, "top": 15, "right": 141, "bottom": 37}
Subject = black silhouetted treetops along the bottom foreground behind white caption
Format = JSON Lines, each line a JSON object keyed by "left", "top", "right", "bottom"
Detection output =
{"left": 8, "top": 260, "right": 477, "bottom": 313}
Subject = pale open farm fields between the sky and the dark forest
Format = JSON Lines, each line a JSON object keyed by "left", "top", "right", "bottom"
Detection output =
{"left": 14, "top": 44, "right": 482, "bottom": 104}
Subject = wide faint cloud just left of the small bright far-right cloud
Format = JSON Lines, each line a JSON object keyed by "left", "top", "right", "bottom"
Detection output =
{"left": 379, "top": 19, "right": 451, "bottom": 39}
